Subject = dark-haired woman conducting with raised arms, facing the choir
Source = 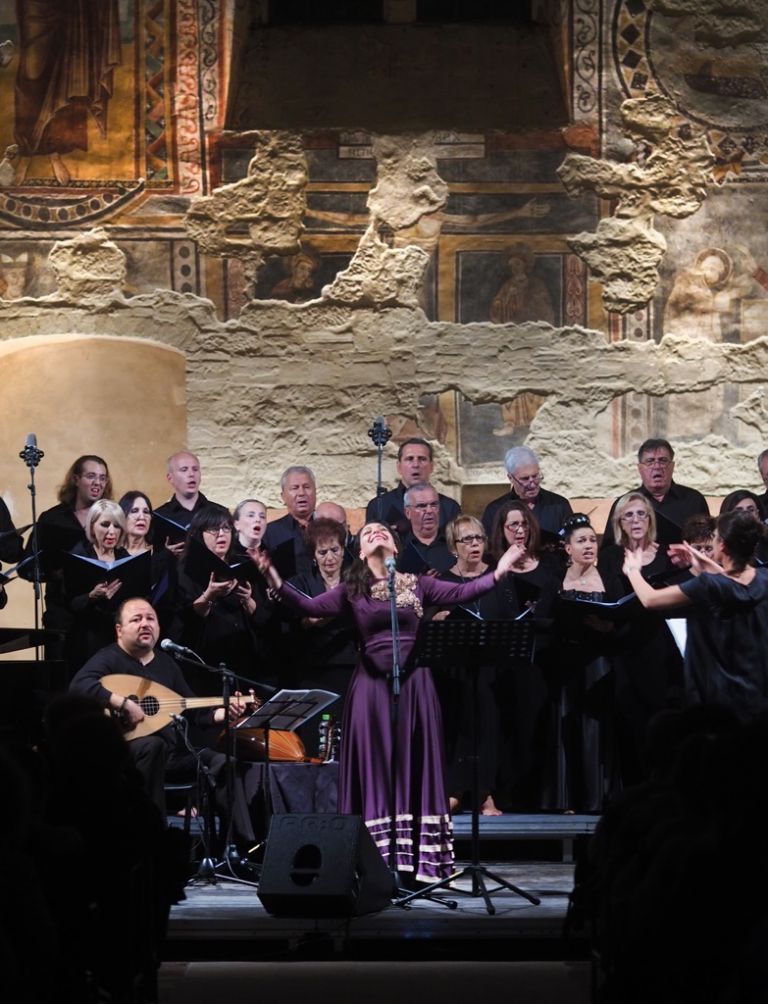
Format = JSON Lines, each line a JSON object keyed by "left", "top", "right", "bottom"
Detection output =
{"left": 623, "top": 511, "right": 768, "bottom": 721}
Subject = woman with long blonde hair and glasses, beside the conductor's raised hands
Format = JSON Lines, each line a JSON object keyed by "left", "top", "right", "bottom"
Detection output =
{"left": 597, "top": 492, "right": 683, "bottom": 785}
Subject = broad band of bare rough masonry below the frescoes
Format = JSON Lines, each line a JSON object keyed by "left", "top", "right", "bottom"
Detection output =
{"left": 0, "top": 236, "right": 768, "bottom": 506}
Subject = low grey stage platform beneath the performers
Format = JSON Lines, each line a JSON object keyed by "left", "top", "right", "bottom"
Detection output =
{"left": 165, "top": 813, "right": 597, "bottom": 961}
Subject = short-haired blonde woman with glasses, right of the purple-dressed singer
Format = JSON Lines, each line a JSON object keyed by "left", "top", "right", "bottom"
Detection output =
{"left": 435, "top": 514, "right": 518, "bottom": 815}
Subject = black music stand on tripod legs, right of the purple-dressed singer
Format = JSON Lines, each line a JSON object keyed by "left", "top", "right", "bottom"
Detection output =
{"left": 398, "top": 611, "right": 541, "bottom": 914}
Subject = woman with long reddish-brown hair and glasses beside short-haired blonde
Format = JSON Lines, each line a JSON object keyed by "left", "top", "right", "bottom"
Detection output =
{"left": 489, "top": 501, "right": 562, "bottom": 812}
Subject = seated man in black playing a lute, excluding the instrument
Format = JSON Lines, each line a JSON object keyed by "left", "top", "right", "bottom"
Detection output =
{"left": 70, "top": 599, "right": 248, "bottom": 840}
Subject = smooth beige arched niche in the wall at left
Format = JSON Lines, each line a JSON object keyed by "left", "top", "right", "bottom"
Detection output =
{"left": 0, "top": 334, "right": 187, "bottom": 646}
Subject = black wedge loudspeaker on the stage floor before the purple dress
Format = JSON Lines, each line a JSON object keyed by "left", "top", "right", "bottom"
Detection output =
{"left": 258, "top": 812, "right": 395, "bottom": 917}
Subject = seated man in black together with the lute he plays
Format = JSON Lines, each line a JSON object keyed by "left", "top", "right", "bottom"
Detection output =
{"left": 70, "top": 599, "right": 245, "bottom": 823}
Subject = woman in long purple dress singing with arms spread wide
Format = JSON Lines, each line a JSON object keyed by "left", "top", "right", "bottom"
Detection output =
{"left": 254, "top": 523, "right": 521, "bottom": 883}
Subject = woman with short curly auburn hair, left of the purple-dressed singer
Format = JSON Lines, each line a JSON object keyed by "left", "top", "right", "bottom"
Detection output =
{"left": 286, "top": 517, "right": 357, "bottom": 756}
